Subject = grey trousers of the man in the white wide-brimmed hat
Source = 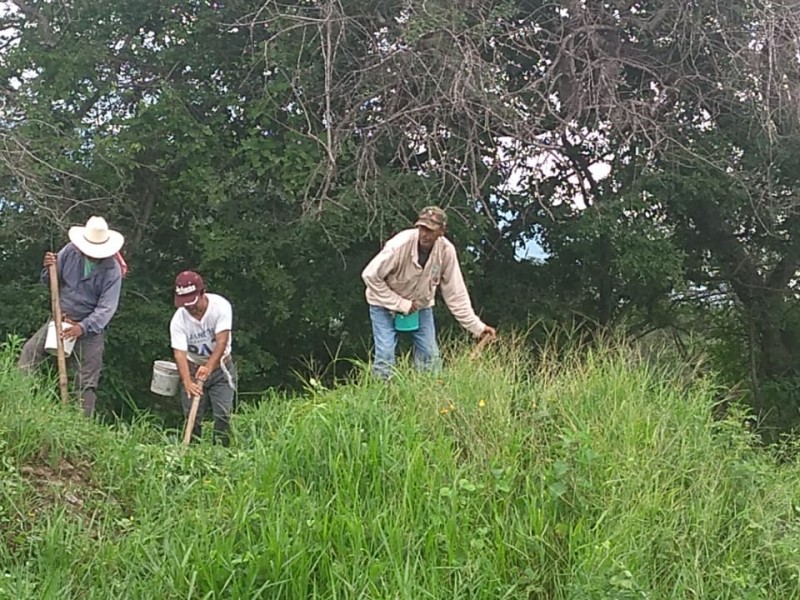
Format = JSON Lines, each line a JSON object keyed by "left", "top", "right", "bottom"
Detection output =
{"left": 17, "top": 324, "right": 105, "bottom": 417}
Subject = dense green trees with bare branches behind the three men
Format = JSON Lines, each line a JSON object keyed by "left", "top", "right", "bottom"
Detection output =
{"left": 0, "top": 0, "right": 800, "bottom": 438}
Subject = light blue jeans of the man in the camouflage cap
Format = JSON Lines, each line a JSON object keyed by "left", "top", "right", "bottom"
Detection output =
{"left": 369, "top": 305, "right": 439, "bottom": 379}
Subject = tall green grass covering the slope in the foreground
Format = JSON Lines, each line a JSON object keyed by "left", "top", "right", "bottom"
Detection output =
{"left": 0, "top": 340, "right": 800, "bottom": 600}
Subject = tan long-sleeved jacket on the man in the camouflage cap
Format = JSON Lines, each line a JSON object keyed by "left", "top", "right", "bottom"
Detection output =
{"left": 361, "top": 229, "right": 486, "bottom": 337}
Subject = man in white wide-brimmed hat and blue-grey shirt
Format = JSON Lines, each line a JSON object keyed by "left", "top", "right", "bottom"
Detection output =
{"left": 18, "top": 216, "right": 125, "bottom": 417}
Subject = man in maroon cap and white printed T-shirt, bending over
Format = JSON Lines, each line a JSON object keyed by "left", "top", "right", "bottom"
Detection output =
{"left": 169, "top": 271, "right": 236, "bottom": 446}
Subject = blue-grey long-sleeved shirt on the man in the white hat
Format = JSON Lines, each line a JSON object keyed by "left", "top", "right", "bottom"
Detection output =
{"left": 42, "top": 243, "right": 122, "bottom": 335}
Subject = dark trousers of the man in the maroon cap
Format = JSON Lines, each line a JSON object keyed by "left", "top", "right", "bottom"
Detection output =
{"left": 181, "top": 358, "right": 236, "bottom": 446}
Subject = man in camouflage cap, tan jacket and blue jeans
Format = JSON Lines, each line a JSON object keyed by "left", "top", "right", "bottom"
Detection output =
{"left": 361, "top": 206, "right": 497, "bottom": 379}
